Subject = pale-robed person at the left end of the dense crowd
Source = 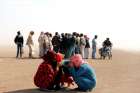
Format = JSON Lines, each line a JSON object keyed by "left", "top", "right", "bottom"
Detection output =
{"left": 38, "top": 32, "right": 45, "bottom": 57}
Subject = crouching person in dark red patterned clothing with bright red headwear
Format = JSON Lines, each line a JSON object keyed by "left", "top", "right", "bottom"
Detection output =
{"left": 34, "top": 50, "right": 62, "bottom": 90}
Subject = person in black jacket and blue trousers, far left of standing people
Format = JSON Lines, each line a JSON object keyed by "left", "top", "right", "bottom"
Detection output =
{"left": 14, "top": 31, "right": 24, "bottom": 58}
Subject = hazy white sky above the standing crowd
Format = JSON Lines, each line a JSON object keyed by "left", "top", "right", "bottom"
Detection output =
{"left": 0, "top": 0, "right": 140, "bottom": 51}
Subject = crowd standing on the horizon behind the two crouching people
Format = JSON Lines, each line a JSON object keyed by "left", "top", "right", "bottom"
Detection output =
{"left": 15, "top": 31, "right": 112, "bottom": 59}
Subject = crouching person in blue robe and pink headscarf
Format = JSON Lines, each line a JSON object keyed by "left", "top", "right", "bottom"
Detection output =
{"left": 63, "top": 54, "right": 96, "bottom": 91}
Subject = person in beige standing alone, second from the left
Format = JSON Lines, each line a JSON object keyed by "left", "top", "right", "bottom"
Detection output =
{"left": 26, "top": 31, "right": 34, "bottom": 58}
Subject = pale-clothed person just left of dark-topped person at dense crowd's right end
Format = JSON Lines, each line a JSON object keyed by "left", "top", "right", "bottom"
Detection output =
{"left": 80, "top": 34, "right": 86, "bottom": 58}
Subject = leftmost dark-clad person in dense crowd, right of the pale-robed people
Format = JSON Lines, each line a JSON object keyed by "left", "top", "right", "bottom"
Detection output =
{"left": 52, "top": 32, "right": 61, "bottom": 53}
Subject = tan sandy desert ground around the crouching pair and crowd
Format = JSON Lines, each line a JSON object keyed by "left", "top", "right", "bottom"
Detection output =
{"left": 0, "top": 46, "right": 140, "bottom": 93}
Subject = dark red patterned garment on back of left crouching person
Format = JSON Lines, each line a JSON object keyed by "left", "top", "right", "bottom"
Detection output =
{"left": 34, "top": 62, "right": 56, "bottom": 89}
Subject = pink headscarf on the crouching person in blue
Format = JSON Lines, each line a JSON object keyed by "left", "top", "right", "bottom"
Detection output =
{"left": 70, "top": 54, "right": 86, "bottom": 67}
